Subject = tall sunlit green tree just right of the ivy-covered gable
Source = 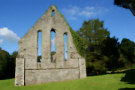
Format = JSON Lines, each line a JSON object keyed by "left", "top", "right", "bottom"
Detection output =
{"left": 77, "top": 19, "right": 110, "bottom": 74}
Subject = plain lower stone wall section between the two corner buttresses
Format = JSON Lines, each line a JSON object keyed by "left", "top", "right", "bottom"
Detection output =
{"left": 25, "top": 69, "right": 79, "bottom": 85}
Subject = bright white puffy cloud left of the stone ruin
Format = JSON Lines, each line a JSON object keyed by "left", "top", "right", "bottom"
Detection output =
{"left": 0, "top": 27, "right": 20, "bottom": 42}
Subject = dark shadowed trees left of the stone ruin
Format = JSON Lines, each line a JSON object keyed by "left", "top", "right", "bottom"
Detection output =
{"left": 0, "top": 48, "right": 17, "bottom": 79}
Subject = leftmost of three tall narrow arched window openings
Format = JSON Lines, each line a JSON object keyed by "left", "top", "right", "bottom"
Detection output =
{"left": 37, "top": 30, "right": 42, "bottom": 62}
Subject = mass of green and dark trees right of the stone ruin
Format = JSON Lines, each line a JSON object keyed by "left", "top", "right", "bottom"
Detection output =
{"left": 76, "top": 19, "right": 135, "bottom": 74}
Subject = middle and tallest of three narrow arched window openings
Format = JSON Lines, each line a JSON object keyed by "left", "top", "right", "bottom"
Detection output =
{"left": 51, "top": 29, "right": 56, "bottom": 62}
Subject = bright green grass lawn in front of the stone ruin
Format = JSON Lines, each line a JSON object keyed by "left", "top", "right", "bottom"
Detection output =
{"left": 0, "top": 74, "right": 135, "bottom": 90}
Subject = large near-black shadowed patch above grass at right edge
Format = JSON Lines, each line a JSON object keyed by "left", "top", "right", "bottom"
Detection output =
{"left": 121, "top": 69, "right": 135, "bottom": 84}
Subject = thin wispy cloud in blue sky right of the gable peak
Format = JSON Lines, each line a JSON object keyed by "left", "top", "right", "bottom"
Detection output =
{"left": 62, "top": 6, "right": 108, "bottom": 20}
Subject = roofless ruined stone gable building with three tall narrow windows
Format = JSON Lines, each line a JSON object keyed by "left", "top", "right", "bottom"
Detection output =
{"left": 15, "top": 5, "right": 86, "bottom": 86}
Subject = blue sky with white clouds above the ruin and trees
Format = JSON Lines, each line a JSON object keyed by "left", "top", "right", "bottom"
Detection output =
{"left": 0, "top": 0, "right": 135, "bottom": 54}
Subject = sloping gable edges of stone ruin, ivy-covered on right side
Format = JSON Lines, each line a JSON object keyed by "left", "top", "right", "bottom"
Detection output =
{"left": 19, "top": 5, "right": 86, "bottom": 57}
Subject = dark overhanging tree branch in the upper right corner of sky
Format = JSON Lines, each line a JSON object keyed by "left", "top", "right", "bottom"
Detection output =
{"left": 114, "top": 0, "right": 135, "bottom": 16}
